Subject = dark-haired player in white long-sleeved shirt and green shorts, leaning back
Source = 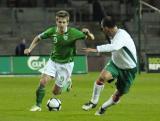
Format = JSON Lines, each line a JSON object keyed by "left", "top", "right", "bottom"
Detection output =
{"left": 82, "top": 16, "right": 137, "bottom": 115}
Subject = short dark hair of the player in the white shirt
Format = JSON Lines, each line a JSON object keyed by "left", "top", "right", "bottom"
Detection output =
{"left": 101, "top": 16, "right": 116, "bottom": 28}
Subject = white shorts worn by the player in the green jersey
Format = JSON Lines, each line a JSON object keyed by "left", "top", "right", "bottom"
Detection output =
{"left": 39, "top": 59, "right": 74, "bottom": 87}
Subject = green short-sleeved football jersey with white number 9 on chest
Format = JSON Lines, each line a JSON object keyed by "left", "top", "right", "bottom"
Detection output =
{"left": 39, "top": 26, "right": 86, "bottom": 63}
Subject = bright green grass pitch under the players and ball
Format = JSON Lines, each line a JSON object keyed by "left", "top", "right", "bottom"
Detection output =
{"left": 0, "top": 72, "right": 160, "bottom": 121}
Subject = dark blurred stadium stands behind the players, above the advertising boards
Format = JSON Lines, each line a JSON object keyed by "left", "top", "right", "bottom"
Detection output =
{"left": 0, "top": 0, "right": 160, "bottom": 71}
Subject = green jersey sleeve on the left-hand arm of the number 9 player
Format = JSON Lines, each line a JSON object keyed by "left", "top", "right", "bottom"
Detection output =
{"left": 38, "top": 28, "right": 54, "bottom": 39}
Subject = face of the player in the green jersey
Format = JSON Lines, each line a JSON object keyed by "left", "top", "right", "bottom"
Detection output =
{"left": 56, "top": 17, "right": 68, "bottom": 31}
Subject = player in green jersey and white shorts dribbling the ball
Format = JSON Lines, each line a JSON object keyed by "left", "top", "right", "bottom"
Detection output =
{"left": 24, "top": 10, "right": 94, "bottom": 111}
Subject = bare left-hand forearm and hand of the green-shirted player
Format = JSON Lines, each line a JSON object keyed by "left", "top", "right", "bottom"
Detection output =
{"left": 24, "top": 36, "right": 40, "bottom": 55}
